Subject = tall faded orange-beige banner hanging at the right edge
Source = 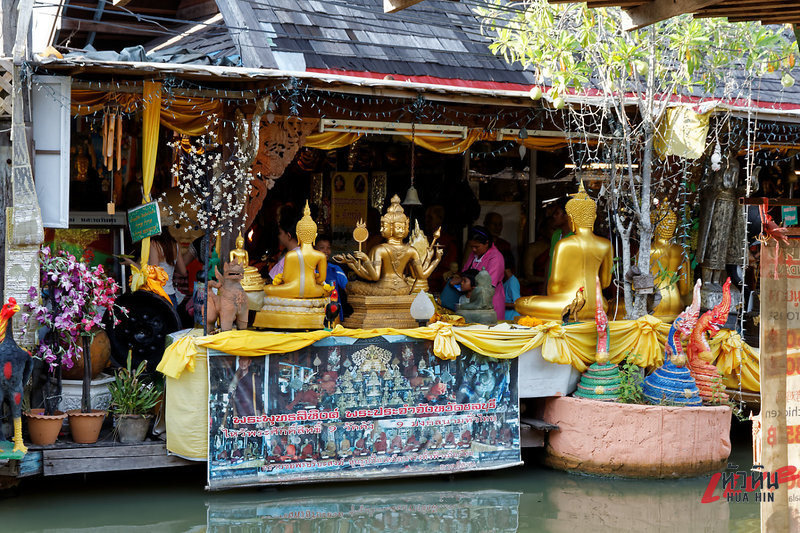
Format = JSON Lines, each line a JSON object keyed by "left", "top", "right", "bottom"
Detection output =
{"left": 760, "top": 235, "right": 800, "bottom": 532}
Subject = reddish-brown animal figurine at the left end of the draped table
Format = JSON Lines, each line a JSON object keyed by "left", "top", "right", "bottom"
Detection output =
{"left": 206, "top": 262, "right": 247, "bottom": 331}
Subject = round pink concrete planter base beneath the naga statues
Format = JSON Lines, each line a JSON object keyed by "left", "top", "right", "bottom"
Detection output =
{"left": 543, "top": 397, "right": 731, "bottom": 478}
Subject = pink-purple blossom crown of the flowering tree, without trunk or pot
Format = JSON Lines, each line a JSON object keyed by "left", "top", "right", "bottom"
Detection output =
{"left": 22, "top": 247, "right": 125, "bottom": 368}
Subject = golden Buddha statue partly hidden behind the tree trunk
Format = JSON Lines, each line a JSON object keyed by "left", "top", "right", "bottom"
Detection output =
{"left": 650, "top": 208, "right": 692, "bottom": 322}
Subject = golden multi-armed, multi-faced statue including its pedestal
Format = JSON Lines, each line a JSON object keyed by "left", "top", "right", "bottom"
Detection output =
{"left": 333, "top": 195, "right": 444, "bottom": 328}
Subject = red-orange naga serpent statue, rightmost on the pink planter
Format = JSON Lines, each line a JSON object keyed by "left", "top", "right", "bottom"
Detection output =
{"left": 687, "top": 278, "right": 731, "bottom": 403}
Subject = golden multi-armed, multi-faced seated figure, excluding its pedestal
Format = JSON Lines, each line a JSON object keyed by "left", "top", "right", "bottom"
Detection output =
{"left": 334, "top": 195, "right": 444, "bottom": 296}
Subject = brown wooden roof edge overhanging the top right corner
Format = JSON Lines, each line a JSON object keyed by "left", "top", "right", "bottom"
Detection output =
{"left": 549, "top": 0, "right": 800, "bottom": 30}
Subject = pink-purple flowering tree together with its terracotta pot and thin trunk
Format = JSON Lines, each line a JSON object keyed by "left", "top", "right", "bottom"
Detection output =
{"left": 22, "top": 247, "right": 124, "bottom": 444}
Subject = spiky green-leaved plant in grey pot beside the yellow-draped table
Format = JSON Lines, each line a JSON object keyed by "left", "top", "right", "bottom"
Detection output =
{"left": 108, "top": 352, "right": 161, "bottom": 443}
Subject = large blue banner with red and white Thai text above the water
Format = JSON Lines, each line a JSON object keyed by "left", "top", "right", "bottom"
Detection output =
{"left": 208, "top": 336, "right": 520, "bottom": 490}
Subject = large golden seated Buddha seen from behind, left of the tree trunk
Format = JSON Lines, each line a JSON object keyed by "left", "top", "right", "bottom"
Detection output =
{"left": 514, "top": 182, "right": 613, "bottom": 321}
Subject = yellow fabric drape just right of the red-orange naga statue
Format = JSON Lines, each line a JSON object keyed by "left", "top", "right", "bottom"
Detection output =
{"left": 708, "top": 329, "right": 761, "bottom": 391}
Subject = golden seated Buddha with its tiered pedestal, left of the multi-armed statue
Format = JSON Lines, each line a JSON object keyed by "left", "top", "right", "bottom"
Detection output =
{"left": 253, "top": 202, "right": 332, "bottom": 329}
